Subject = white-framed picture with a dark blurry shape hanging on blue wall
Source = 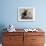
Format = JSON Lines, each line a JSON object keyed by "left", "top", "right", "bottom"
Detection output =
{"left": 18, "top": 7, "right": 35, "bottom": 21}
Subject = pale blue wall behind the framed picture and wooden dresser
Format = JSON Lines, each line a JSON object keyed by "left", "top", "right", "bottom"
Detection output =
{"left": 0, "top": 0, "right": 46, "bottom": 28}
